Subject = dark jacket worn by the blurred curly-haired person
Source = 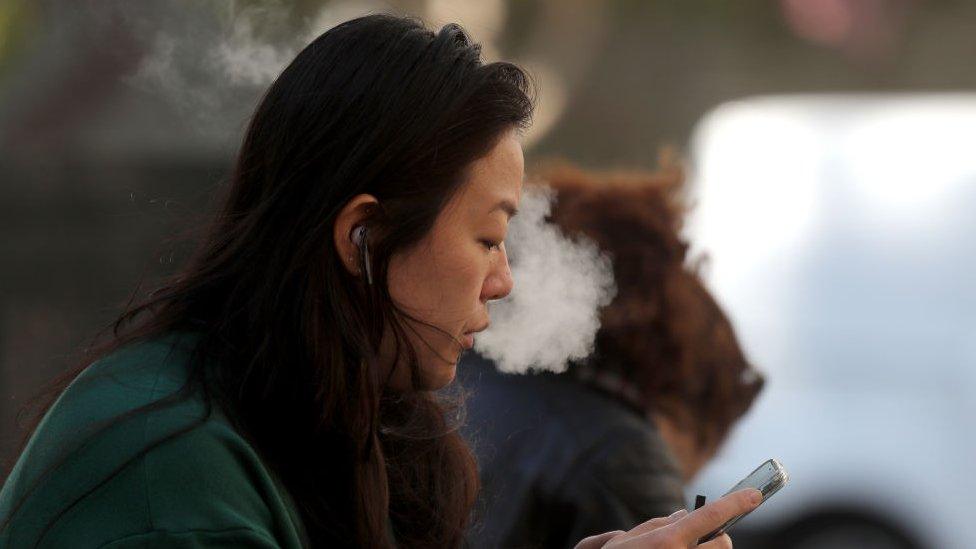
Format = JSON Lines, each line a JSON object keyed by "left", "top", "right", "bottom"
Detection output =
{"left": 458, "top": 356, "right": 684, "bottom": 548}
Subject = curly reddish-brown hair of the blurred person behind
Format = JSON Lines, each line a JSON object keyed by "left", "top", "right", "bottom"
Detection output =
{"left": 540, "top": 155, "right": 763, "bottom": 450}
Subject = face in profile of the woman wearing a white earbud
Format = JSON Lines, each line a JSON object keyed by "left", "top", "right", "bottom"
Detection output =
{"left": 384, "top": 130, "right": 524, "bottom": 390}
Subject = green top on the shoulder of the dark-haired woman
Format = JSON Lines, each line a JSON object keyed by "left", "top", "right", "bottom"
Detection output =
{"left": 0, "top": 332, "right": 298, "bottom": 547}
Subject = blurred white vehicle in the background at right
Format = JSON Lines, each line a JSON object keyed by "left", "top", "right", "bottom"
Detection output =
{"left": 688, "top": 94, "right": 976, "bottom": 549}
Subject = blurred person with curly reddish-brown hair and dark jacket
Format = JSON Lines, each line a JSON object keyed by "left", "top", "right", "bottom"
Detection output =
{"left": 458, "top": 161, "right": 762, "bottom": 548}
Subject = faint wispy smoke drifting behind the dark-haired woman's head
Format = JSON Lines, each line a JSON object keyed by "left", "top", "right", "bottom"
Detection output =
{"left": 122, "top": 0, "right": 382, "bottom": 137}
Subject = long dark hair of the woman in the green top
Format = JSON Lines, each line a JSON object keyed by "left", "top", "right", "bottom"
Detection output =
{"left": 5, "top": 15, "right": 532, "bottom": 547}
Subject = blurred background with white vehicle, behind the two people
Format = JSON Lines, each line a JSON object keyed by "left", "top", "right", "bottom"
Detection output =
{"left": 0, "top": 0, "right": 976, "bottom": 548}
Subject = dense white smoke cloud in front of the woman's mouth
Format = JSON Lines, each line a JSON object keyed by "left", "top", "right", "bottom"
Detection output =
{"left": 475, "top": 185, "right": 616, "bottom": 373}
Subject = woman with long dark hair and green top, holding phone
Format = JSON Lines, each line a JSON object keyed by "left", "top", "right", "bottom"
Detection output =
{"left": 0, "top": 16, "right": 750, "bottom": 548}
